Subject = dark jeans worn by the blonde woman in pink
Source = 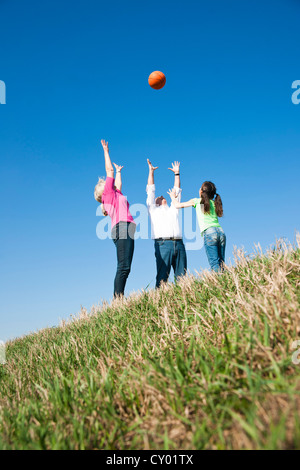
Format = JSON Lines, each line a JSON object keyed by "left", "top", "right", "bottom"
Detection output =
{"left": 111, "top": 222, "right": 136, "bottom": 297}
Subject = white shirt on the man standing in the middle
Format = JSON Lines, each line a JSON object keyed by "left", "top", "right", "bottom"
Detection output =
{"left": 146, "top": 184, "right": 182, "bottom": 239}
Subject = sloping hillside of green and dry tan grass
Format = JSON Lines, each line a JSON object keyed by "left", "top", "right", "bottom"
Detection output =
{"left": 0, "top": 241, "right": 300, "bottom": 449}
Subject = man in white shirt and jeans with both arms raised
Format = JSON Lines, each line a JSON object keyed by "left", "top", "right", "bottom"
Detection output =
{"left": 146, "top": 160, "right": 187, "bottom": 288}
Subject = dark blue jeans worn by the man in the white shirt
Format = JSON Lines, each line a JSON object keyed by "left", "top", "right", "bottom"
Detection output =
{"left": 154, "top": 240, "right": 187, "bottom": 287}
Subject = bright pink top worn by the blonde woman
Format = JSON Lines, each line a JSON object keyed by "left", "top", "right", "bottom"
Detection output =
{"left": 102, "top": 176, "right": 134, "bottom": 228}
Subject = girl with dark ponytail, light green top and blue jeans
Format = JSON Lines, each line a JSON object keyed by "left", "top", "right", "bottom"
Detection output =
{"left": 168, "top": 181, "right": 226, "bottom": 272}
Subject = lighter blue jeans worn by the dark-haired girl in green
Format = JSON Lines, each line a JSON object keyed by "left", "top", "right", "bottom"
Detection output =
{"left": 204, "top": 227, "right": 226, "bottom": 272}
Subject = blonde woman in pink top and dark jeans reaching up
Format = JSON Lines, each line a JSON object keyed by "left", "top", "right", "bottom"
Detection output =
{"left": 94, "top": 140, "right": 136, "bottom": 297}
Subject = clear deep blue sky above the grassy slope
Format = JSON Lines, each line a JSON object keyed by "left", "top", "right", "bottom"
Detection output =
{"left": 0, "top": 0, "right": 300, "bottom": 340}
